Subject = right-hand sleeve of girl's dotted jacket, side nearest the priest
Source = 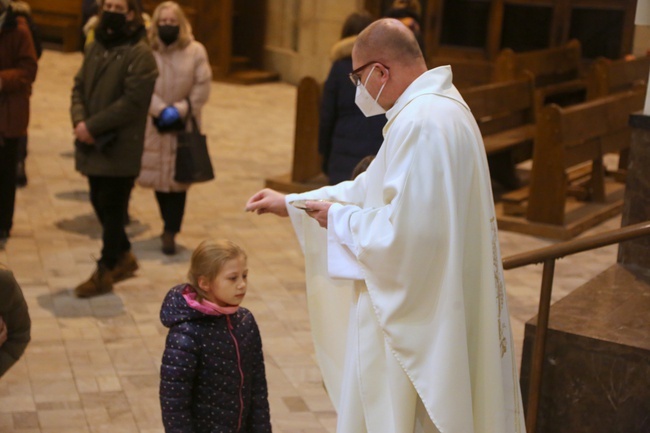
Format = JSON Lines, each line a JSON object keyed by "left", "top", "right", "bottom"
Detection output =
{"left": 247, "top": 317, "right": 272, "bottom": 433}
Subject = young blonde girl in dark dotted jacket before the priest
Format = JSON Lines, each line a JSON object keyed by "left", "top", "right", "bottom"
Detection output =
{"left": 160, "top": 240, "right": 271, "bottom": 433}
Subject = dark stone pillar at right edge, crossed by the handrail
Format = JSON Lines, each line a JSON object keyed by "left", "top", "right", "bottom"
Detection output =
{"left": 618, "top": 113, "right": 650, "bottom": 269}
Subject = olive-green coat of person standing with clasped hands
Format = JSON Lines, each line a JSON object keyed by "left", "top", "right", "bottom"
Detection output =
{"left": 70, "top": 27, "right": 158, "bottom": 177}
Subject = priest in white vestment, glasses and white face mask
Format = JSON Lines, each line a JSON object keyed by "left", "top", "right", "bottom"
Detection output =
{"left": 246, "top": 19, "right": 525, "bottom": 433}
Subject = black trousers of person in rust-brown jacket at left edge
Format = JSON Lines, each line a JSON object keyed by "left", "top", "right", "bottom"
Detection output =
{"left": 0, "top": 137, "right": 20, "bottom": 232}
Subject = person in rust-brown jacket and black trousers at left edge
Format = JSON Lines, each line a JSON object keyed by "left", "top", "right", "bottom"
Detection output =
{"left": 0, "top": 0, "right": 38, "bottom": 246}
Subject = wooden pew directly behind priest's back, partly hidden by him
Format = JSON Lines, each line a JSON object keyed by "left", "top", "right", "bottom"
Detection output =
{"left": 461, "top": 73, "right": 535, "bottom": 189}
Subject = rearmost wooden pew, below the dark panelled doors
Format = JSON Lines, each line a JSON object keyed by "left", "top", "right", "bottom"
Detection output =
{"left": 492, "top": 40, "right": 586, "bottom": 108}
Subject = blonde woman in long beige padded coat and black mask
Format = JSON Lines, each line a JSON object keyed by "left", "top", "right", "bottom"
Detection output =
{"left": 138, "top": 1, "right": 212, "bottom": 254}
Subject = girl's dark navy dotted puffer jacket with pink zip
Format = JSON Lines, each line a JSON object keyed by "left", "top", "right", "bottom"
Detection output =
{"left": 160, "top": 285, "right": 271, "bottom": 433}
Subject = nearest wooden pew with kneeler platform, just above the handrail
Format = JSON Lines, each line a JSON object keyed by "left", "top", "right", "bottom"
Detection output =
{"left": 497, "top": 89, "right": 645, "bottom": 239}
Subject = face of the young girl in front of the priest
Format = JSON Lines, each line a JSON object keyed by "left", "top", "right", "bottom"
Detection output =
{"left": 199, "top": 256, "right": 248, "bottom": 307}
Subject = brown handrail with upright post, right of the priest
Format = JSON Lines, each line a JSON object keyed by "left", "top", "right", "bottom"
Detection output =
{"left": 503, "top": 221, "right": 650, "bottom": 433}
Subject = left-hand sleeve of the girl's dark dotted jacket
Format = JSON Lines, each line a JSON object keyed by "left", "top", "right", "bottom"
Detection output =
{"left": 160, "top": 323, "right": 198, "bottom": 433}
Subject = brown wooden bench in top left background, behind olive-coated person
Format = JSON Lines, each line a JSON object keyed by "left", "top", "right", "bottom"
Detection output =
{"left": 28, "top": 0, "right": 81, "bottom": 52}
